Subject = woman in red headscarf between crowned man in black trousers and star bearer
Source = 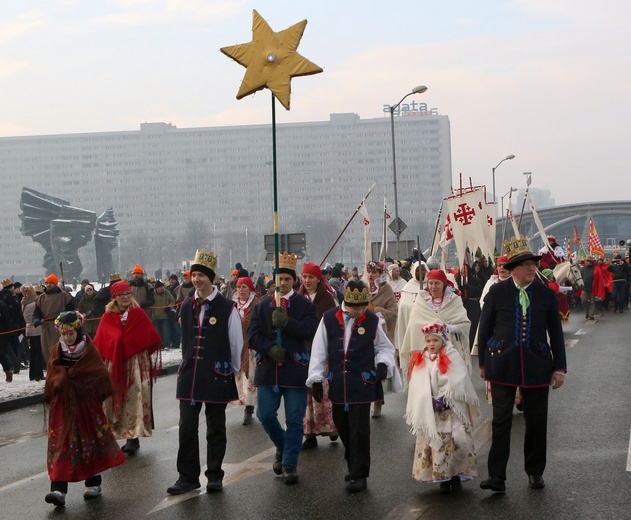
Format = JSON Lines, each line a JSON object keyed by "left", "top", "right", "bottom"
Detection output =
{"left": 234, "top": 276, "right": 259, "bottom": 426}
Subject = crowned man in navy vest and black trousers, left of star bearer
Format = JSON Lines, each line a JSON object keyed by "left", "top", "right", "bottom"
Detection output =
{"left": 167, "top": 249, "right": 243, "bottom": 495}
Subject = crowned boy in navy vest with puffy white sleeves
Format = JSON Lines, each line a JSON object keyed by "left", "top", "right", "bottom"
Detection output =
{"left": 307, "top": 280, "right": 395, "bottom": 493}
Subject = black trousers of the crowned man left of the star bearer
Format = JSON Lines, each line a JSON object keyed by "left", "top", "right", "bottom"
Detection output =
{"left": 177, "top": 401, "right": 226, "bottom": 483}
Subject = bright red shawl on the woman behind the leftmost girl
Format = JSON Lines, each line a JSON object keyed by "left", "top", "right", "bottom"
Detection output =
{"left": 94, "top": 308, "right": 162, "bottom": 404}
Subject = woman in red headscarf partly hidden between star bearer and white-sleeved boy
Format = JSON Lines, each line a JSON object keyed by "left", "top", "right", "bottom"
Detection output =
{"left": 298, "top": 262, "right": 338, "bottom": 450}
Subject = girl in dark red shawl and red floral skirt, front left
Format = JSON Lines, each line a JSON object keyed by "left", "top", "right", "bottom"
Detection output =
{"left": 44, "top": 311, "right": 125, "bottom": 506}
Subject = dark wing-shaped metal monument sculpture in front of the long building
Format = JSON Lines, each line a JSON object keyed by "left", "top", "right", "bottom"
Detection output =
{"left": 20, "top": 188, "right": 119, "bottom": 278}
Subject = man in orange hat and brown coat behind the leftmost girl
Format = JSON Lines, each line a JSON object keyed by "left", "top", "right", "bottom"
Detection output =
{"left": 33, "top": 273, "right": 75, "bottom": 366}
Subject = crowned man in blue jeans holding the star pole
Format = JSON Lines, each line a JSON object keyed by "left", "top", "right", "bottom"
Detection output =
{"left": 247, "top": 253, "right": 319, "bottom": 484}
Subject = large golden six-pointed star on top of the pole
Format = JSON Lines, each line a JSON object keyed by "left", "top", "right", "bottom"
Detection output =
{"left": 220, "top": 10, "right": 322, "bottom": 110}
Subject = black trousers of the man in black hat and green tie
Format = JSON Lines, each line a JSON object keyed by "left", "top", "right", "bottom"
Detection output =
{"left": 488, "top": 384, "right": 550, "bottom": 480}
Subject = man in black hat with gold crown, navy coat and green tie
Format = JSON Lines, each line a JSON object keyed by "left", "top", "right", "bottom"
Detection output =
{"left": 478, "top": 236, "right": 566, "bottom": 493}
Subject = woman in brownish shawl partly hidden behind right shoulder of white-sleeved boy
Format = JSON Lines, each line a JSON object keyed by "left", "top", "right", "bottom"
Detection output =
{"left": 364, "top": 261, "right": 399, "bottom": 417}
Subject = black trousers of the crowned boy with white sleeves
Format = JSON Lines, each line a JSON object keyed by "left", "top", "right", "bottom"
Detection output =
{"left": 333, "top": 403, "right": 370, "bottom": 478}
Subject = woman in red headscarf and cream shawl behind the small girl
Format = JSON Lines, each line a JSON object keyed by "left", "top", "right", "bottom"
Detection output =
{"left": 400, "top": 269, "right": 471, "bottom": 380}
